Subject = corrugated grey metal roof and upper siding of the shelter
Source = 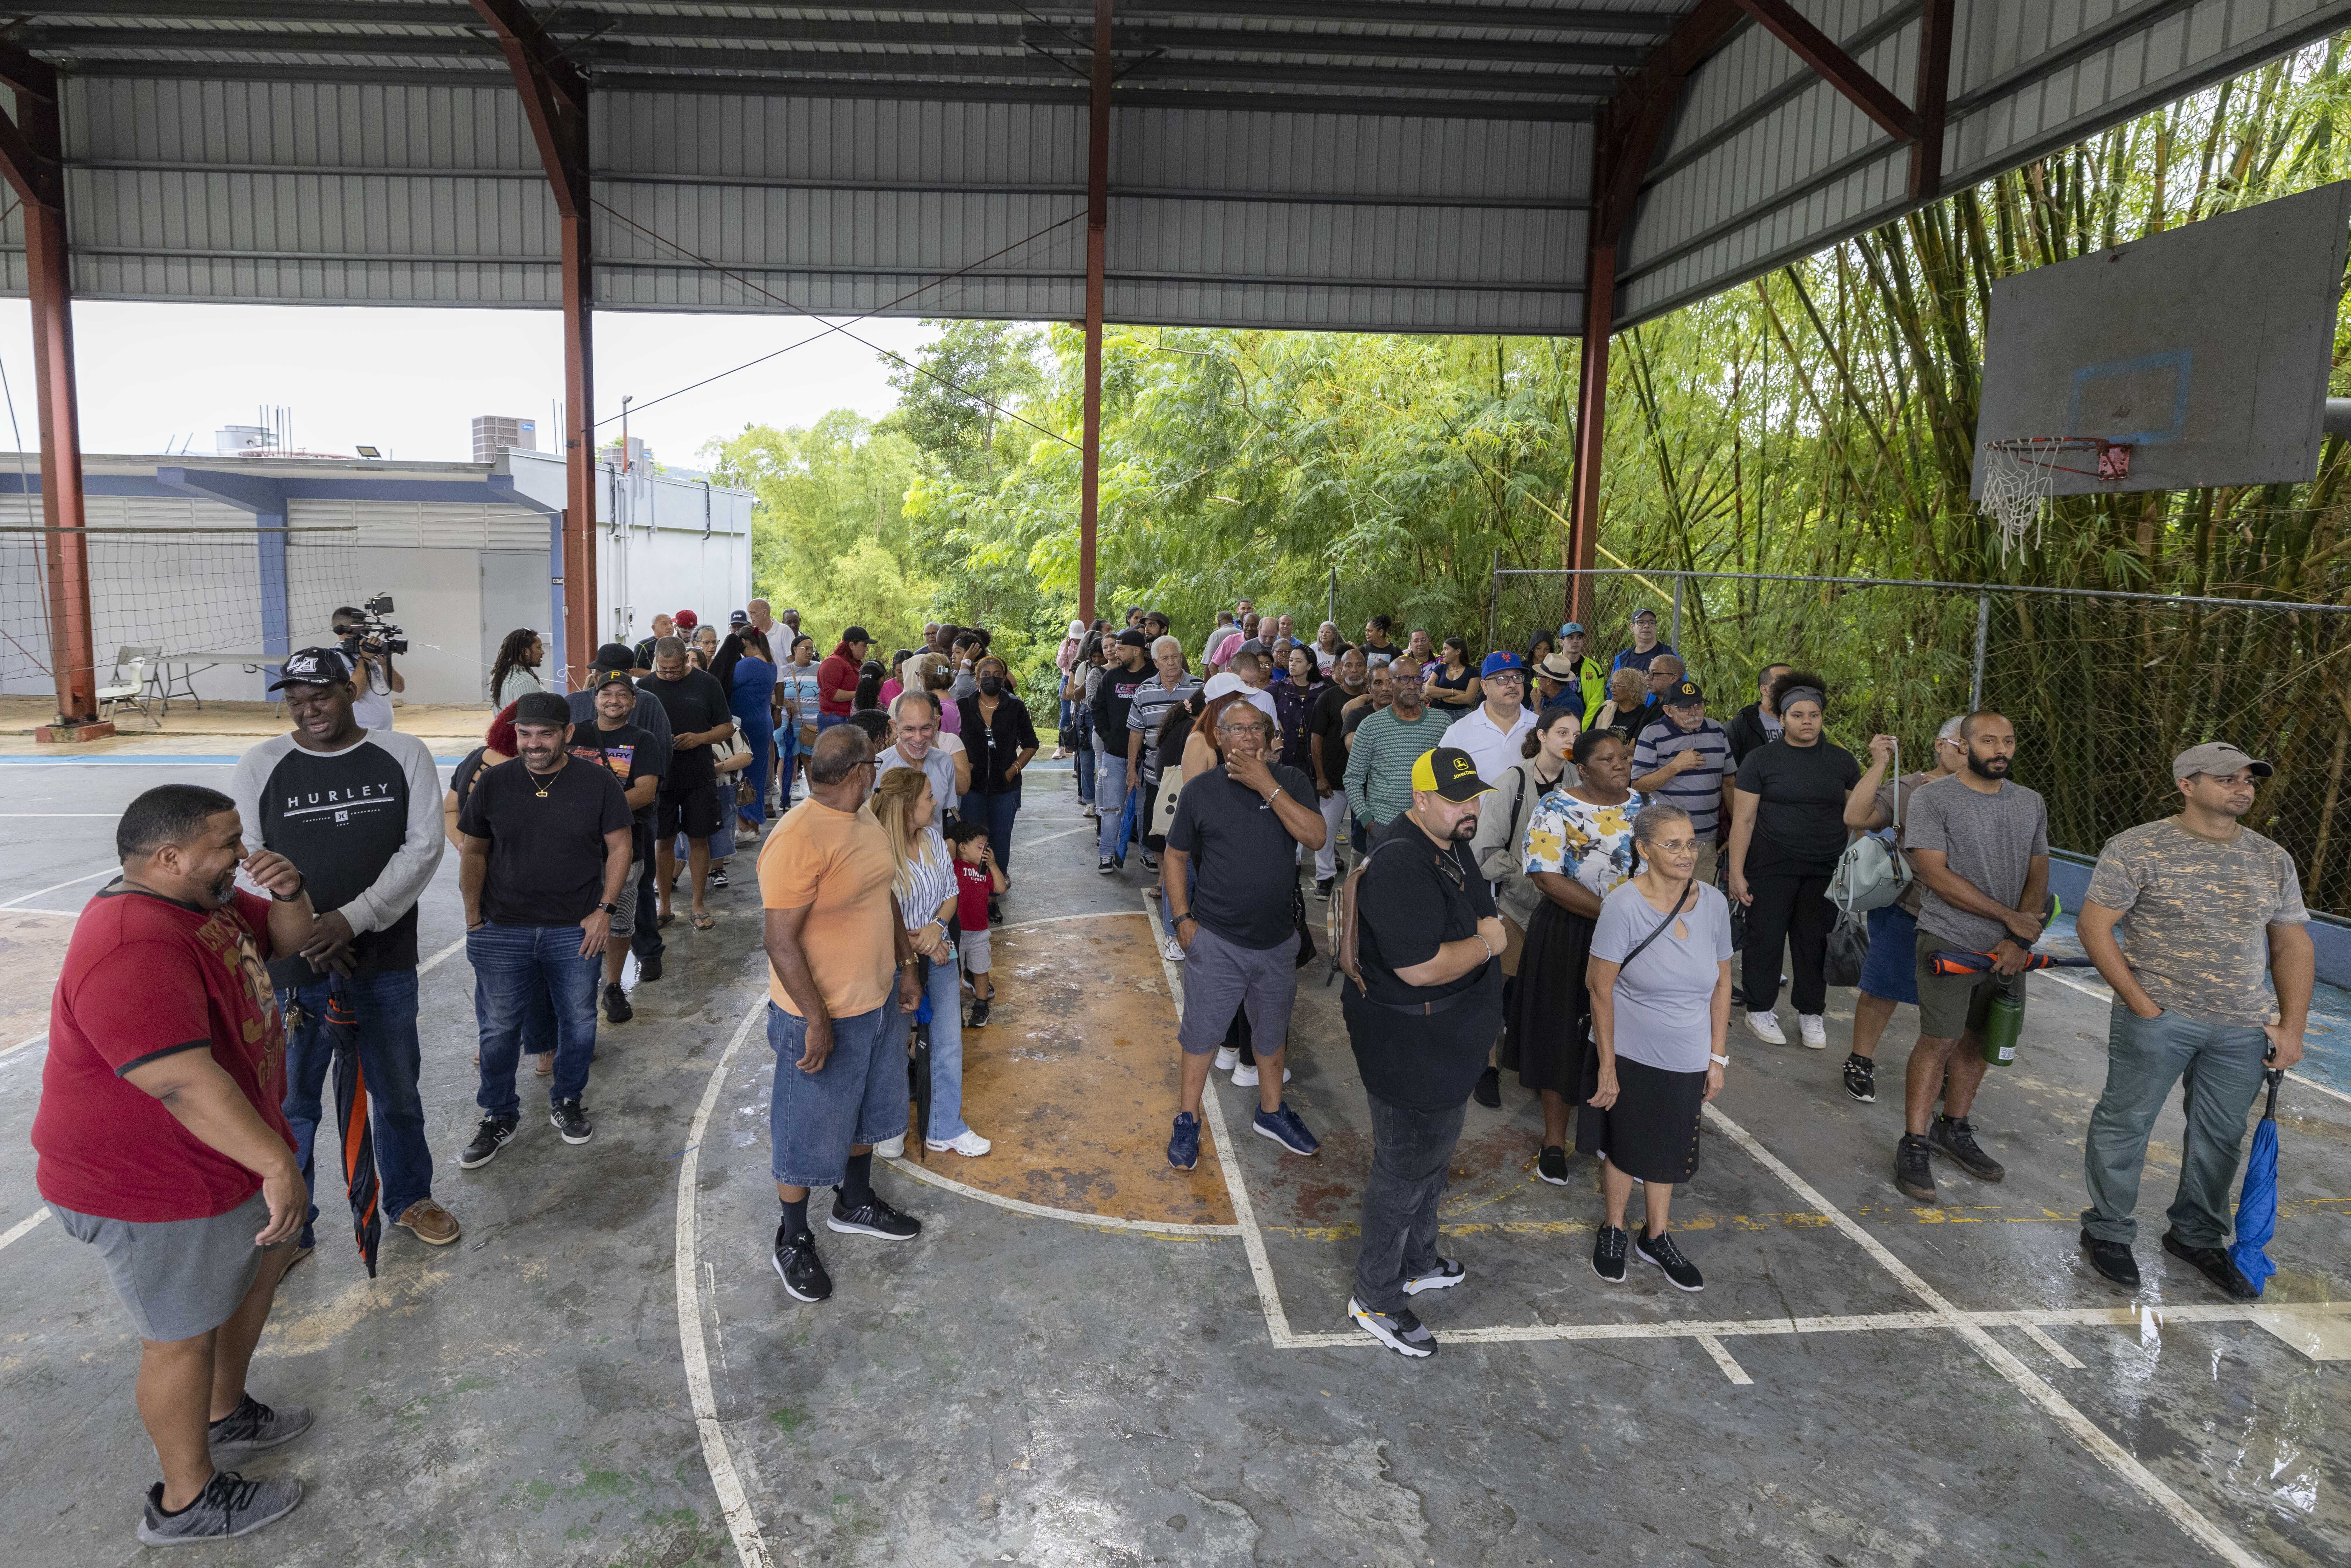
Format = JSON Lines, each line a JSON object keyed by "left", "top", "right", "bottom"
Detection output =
{"left": 0, "top": 0, "right": 2351, "bottom": 334}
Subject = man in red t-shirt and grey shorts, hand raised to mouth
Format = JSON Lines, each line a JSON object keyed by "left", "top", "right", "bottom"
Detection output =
{"left": 33, "top": 785, "right": 317, "bottom": 1544}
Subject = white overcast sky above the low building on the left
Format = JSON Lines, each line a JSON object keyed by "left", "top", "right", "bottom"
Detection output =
{"left": 0, "top": 301, "right": 929, "bottom": 468}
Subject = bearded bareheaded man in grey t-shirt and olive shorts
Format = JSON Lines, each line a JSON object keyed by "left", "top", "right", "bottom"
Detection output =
{"left": 1895, "top": 712, "right": 2050, "bottom": 1204}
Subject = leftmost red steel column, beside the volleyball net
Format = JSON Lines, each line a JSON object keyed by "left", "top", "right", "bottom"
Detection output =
{"left": 0, "top": 49, "right": 113, "bottom": 741}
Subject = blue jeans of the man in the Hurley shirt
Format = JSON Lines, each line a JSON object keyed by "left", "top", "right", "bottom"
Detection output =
{"left": 277, "top": 969, "right": 432, "bottom": 1246}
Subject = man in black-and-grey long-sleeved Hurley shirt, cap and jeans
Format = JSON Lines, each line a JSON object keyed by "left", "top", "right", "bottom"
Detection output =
{"left": 228, "top": 649, "right": 459, "bottom": 1262}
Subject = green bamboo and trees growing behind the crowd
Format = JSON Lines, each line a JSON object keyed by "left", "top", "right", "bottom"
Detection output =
{"left": 719, "top": 38, "right": 2351, "bottom": 912}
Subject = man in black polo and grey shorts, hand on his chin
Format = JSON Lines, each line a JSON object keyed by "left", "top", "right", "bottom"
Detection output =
{"left": 1159, "top": 703, "right": 1326, "bottom": 1171}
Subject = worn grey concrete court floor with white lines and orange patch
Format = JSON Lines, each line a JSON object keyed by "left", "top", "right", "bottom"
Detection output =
{"left": 0, "top": 764, "right": 2351, "bottom": 1566}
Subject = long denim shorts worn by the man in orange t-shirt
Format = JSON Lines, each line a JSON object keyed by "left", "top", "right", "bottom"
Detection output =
{"left": 766, "top": 1006, "right": 912, "bottom": 1187}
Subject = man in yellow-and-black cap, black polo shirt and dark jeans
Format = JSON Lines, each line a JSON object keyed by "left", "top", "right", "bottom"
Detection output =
{"left": 1340, "top": 745, "right": 1502, "bottom": 1356}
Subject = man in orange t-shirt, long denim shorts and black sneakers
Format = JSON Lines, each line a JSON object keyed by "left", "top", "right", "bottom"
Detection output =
{"left": 759, "top": 724, "right": 922, "bottom": 1302}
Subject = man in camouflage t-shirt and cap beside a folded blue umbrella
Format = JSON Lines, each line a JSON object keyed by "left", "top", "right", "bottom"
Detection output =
{"left": 2078, "top": 741, "right": 2316, "bottom": 1300}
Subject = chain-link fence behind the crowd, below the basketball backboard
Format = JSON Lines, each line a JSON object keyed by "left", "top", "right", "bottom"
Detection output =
{"left": 1491, "top": 569, "right": 2351, "bottom": 917}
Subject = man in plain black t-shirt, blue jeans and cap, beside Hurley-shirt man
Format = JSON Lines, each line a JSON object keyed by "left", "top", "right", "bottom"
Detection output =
{"left": 456, "top": 691, "right": 635, "bottom": 1171}
